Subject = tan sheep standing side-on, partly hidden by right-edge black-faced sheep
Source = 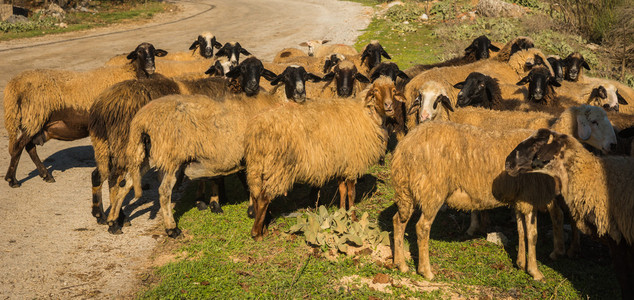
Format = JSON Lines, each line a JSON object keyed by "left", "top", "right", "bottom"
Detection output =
{"left": 391, "top": 109, "right": 616, "bottom": 280}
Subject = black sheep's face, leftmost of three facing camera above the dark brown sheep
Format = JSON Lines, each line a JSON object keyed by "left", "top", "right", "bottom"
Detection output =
{"left": 225, "top": 57, "right": 277, "bottom": 97}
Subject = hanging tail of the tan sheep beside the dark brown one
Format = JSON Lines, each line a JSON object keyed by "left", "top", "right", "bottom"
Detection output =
{"left": 126, "top": 120, "right": 151, "bottom": 198}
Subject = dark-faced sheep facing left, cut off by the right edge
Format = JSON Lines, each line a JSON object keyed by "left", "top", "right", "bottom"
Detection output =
{"left": 505, "top": 129, "right": 634, "bottom": 299}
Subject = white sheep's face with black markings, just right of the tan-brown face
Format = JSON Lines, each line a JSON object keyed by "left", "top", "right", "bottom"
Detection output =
{"left": 407, "top": 81, "right": 453, "bottom": 124}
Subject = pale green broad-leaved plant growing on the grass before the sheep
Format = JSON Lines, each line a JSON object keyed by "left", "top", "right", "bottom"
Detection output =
{"left": 288, "top": 205, "right": 390, "bottom": 253}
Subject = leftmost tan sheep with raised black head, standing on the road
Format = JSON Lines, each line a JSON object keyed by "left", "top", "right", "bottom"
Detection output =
{"left": 4, "top": 43, "right": 167, "bottom": 187}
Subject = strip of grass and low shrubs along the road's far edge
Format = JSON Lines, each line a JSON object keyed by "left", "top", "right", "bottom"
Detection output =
{"left": 0, "top": 0, "right": 177, "bottom": 41}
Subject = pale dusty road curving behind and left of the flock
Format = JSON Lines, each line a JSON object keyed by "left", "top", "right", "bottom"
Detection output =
{"left": 0, "top": 0, "right": 371, "bottom": 299}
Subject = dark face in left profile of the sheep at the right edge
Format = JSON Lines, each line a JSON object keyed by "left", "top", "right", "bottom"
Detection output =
{"left": 504, "top": 129, "right": 569, "bottom": 178}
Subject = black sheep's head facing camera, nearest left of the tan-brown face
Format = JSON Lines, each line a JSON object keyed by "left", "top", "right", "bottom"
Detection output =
{"left": 311, "top": 60, "right": 370, "bottom": 98}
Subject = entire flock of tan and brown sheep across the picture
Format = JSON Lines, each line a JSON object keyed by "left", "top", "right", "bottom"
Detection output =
{"left": 4, "top": 32, "right": 634, "bottom": 298}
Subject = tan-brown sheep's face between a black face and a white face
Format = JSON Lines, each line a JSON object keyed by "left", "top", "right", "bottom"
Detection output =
{"left": 365, "top": 76, "right": 405, "bottom": 117}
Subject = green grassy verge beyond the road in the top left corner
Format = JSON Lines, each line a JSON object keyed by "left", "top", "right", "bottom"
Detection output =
{"left": 0, "top": 1, "right": 174, "bottom": 41}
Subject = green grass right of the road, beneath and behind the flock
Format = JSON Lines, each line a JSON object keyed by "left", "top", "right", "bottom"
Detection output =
{"left": 138, "top": 0, "right": 634, "bottom": 299}
